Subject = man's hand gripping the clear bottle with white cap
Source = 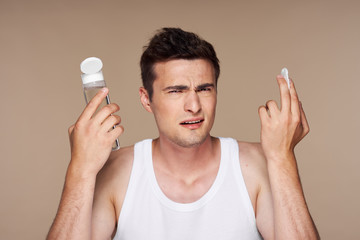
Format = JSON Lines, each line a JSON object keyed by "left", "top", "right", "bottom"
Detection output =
{"left": 69, "top": 88, "right": 124, "bottom": 176}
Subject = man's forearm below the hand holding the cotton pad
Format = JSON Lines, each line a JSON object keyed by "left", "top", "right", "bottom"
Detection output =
{"left": 268, "top": 154, "right": 320, "bottom": 239}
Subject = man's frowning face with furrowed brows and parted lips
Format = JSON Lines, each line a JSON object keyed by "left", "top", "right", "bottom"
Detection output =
{"left": 146, "top": 59, "right": 217, "bottom": 147}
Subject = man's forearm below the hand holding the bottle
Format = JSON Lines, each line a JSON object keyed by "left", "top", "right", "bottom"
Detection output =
{"left": 47, "top": 162, "right": 96, "bottom": 240}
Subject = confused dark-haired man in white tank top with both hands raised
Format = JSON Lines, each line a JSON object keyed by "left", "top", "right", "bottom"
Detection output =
{"left": 48, "top": 28, "right": 319, "bottom": 240}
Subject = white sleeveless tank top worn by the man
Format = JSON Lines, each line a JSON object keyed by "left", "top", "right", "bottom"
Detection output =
{"left": 114, "top": 138, "right": 262, "bottom": 240}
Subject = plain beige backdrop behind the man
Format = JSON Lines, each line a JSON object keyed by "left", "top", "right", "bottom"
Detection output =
{"left": 0, "top": 0, "right": 360, "bottom": 239}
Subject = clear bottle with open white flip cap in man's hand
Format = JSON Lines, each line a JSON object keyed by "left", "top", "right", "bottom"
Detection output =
{"left": 80, "top": 57, "right": 120, "bottom": 151}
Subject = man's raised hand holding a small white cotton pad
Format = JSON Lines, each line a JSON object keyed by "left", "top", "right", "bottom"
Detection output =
{"left": 259, "top": 75, "right": 309, "bottom": 160}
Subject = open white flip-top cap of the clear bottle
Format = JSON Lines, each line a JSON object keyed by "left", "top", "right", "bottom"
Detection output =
{"left": 80, "top": 57, "right": 104, "bottom": 84}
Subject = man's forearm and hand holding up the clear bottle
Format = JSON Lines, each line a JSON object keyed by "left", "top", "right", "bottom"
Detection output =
{"left": 47, "top": 88, "right": 123, "bottom": 239}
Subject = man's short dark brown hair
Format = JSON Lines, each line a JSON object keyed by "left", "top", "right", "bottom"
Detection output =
{"left": 140, "top": 28, "right": 220, "bottom": 101}
